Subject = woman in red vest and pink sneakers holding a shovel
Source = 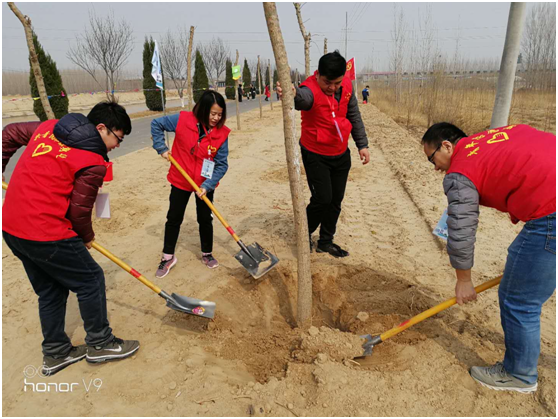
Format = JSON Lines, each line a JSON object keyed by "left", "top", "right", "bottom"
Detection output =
{"left": 151, "top": 90, "right": 231, "bottom": 278}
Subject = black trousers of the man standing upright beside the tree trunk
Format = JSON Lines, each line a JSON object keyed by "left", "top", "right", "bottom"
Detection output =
{"left": 301, "top": 147, "right": 351, "bottom": 244}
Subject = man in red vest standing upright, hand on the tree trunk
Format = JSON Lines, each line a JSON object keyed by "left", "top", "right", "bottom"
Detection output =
{"left": 277, "top": 51, "right": 370, "bottom": 257}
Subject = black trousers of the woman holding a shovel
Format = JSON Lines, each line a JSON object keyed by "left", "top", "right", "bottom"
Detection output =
{"left": 163, "top": 185, "right": 215, "bottom": 255}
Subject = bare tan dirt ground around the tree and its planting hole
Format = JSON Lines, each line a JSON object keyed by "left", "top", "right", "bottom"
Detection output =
{"left": 2, "top": 105, "right": 556, "bottom": 416}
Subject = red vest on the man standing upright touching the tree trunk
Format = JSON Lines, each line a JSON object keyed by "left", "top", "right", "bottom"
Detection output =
{"left": 300, "top": 72, "right": 353, "bottom": 156}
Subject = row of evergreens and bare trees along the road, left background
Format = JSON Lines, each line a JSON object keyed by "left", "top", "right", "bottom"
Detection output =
{"left": 13, "top": 4, "right": 290, "bottom": 120}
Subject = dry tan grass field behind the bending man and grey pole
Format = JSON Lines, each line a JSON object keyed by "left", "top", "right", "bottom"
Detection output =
{"left": 367, "top": 78, "right": 556, "bottom": 134}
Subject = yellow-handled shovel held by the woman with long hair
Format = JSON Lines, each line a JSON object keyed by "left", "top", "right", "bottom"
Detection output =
{"left": 169, "top": 153, "right": 279, "bottom": 279}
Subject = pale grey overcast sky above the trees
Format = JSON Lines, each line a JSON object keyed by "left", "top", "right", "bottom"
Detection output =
{"left": 2, "top": 2, "right": 532, "bottom": 74}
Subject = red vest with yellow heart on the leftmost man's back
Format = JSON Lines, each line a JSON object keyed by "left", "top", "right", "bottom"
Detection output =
{"left": 2, "top": 119, "right": 104, "bottom": 241}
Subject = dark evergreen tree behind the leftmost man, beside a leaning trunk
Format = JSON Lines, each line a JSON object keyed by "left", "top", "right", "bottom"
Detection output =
{"left": 29, "top": 33, "right": 70, "bottom": 121}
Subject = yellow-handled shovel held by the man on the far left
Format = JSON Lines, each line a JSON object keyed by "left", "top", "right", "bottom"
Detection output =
{"left": 2, "top": 182, "right": 215, "bottom": 319}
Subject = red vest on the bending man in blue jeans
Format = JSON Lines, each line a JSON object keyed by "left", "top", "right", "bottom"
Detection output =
{"left": 448, "top": 125, "right": 556, "bottom": 224}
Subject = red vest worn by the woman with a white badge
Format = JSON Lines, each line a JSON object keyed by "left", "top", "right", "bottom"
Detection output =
{"left": 167, "top": 112, "right": 231, "bottom": 192}
